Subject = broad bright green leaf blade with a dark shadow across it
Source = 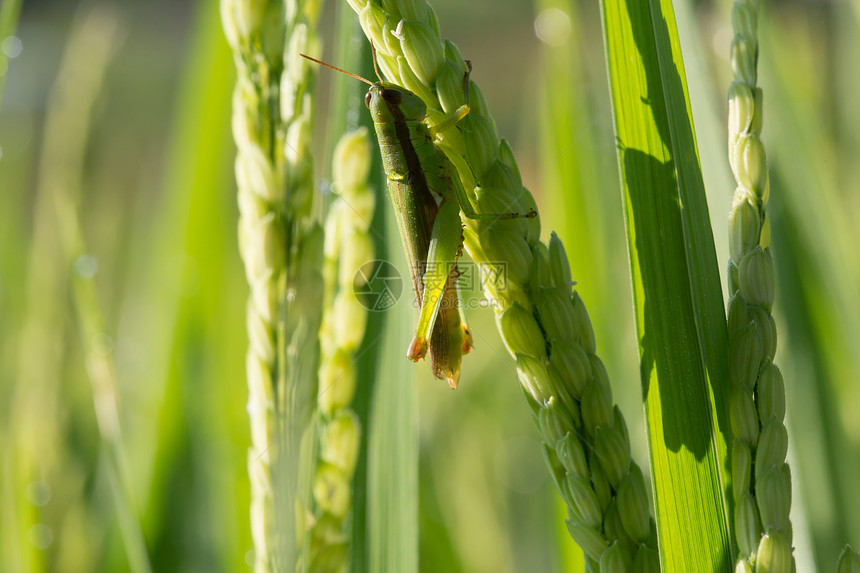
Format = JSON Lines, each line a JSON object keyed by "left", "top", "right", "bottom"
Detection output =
{"left": 603, "top": 0, "right": 733, "bottom": 571}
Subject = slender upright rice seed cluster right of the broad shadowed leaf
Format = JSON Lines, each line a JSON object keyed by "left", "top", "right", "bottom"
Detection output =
{"left": 728, "top": 0, "right": 795, "bottom": 573}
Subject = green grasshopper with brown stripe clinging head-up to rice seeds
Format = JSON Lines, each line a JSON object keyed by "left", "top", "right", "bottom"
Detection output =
{"left": 301, "top": 54, "right": 537, "bottom": 388}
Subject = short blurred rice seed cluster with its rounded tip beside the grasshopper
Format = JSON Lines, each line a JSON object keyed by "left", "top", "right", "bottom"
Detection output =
{"left": 310, "top": 128, "right": 376, "bottom": 572}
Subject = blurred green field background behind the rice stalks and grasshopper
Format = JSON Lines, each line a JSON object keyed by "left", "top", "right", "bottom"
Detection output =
{"left": 0, "top": 0, "right": 860, "bottom": 572}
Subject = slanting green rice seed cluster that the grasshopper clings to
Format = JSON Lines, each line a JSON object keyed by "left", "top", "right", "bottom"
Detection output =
{"left": 342, "top": 0, "right": 659, "bottom": 571}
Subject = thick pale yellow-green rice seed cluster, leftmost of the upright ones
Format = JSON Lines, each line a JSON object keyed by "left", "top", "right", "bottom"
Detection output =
{"left": 221, "top": 0, "right": 322, "bottom": 571}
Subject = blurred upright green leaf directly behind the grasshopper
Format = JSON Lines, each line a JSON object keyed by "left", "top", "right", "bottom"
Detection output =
{"left": 346, "top": 40, "right": 418, "bottom": 573}
